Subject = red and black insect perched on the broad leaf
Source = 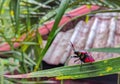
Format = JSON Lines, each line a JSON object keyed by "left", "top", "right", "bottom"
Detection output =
{"left": 70, "top": 42, "right": 95, "bottom": 64}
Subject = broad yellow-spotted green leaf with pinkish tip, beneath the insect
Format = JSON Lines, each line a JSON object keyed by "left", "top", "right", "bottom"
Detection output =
{"left": 5, "top": 57, "right": 120, "bottom": 79}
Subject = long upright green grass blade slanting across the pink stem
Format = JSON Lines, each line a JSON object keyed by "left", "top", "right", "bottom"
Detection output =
{"left": 34, "top": 0, "right": 70, "bottom": 71}
